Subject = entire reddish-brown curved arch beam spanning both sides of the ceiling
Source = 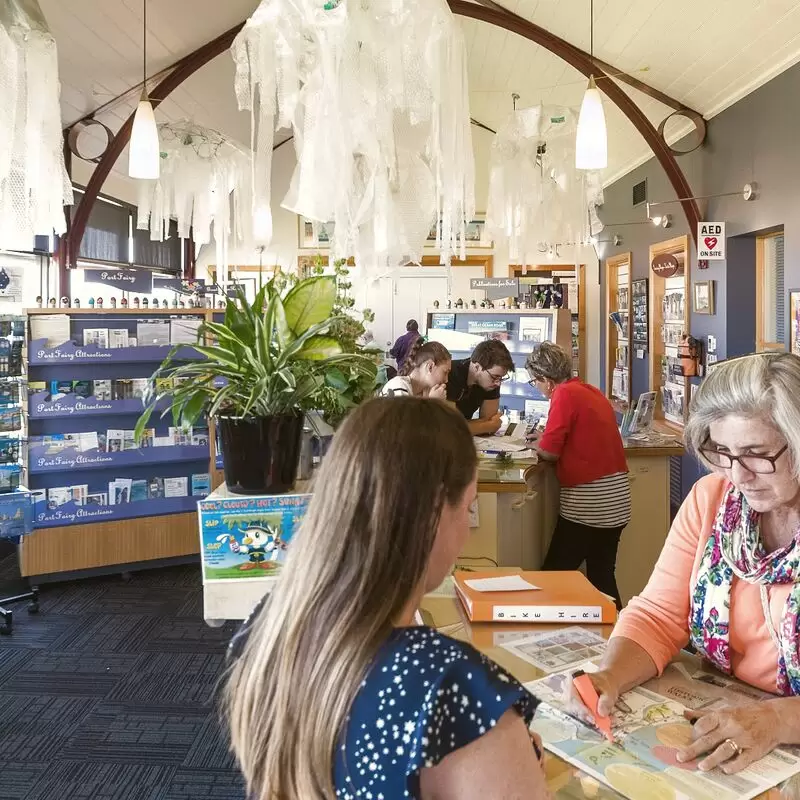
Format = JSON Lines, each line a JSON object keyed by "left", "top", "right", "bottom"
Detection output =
{"left": 65, "top": 0, "right": 700, "bottom": 267}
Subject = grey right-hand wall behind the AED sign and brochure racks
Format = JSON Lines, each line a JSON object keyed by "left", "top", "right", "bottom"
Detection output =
{"left": 599, "top": 65, "right": 800, "bottom": 495}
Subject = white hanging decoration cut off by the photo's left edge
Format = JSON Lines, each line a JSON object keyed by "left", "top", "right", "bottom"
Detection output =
{"left": 0, "top": 0, "right": 73, "bottom": 250}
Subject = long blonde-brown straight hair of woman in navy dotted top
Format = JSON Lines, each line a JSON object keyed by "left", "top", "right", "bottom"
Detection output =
{"left": 224, "top": 398, "right": 477, "bottom": 800}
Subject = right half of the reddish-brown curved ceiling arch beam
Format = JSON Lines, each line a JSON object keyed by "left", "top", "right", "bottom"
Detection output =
{"left": 448, "top": 0, "right": 700, "bottom": 246}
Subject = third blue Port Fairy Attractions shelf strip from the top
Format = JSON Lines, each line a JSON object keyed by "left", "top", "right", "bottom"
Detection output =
{"left": 28, "top": 444, "right": 209, "bottom": 475}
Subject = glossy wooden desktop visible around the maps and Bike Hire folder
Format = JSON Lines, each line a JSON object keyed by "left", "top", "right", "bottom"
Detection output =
{"left": 420, "top": 594, "right": 788, "bottom": 800}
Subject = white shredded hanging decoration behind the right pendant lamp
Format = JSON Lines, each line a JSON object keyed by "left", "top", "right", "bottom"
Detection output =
{"left": 486, "top": 105, "right": 603, "bottom": 264}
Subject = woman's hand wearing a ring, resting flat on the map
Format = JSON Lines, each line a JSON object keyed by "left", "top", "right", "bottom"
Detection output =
{"left": 677, "top": 700, "right": 782, "bottom": 773}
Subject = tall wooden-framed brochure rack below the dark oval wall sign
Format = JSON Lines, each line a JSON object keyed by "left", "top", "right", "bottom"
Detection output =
{"left": 648, "top": 236, "right": 691, "bottom": 429}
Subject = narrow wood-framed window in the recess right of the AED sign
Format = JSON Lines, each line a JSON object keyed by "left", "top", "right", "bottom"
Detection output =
{"left": 756, "top": 230, "right": 786, "bottom": 350}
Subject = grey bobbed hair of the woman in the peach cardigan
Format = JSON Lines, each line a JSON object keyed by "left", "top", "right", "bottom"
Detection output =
{"left": 684, "top": 352, "right": 800, "bottom": 480}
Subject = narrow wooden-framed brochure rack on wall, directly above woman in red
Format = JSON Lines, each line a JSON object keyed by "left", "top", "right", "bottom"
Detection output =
{"left": 606, "top": 253, "right": 632, "bottom": 411}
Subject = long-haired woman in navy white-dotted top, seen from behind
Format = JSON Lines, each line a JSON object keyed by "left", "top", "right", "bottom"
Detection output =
{"left": 224, "top": 397, "right": 549, "bottom": 800}
